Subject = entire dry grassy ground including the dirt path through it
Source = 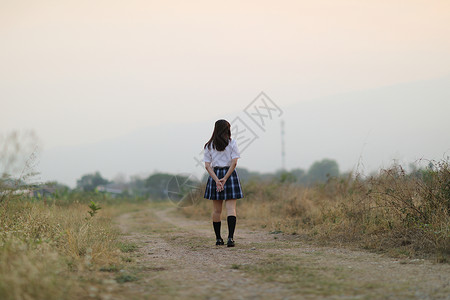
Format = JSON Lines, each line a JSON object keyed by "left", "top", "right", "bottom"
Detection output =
{"left": 0, "top": 162, "right": 450, "bottom": 299}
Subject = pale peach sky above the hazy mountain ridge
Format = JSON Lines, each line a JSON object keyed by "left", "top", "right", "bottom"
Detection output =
{"left": 0, "top": 0, "right": 450, "bottom": 184}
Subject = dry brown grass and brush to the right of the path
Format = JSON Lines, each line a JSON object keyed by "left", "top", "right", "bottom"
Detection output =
{"left": 183, "top": 161, "right": 450, "bottom": 262}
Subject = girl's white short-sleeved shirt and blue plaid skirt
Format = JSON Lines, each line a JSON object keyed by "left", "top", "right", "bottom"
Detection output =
{"left": 203, "top": 139, "right": 244, "bottom": 200}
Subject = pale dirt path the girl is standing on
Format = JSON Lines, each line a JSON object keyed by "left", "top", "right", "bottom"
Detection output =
{"left": 110, "top": 208, "right": 450, "bottom": 299}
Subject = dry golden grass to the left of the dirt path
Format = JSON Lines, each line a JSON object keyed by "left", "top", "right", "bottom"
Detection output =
{"left": 0, "top": 199, "right": 134, "bottom": 299}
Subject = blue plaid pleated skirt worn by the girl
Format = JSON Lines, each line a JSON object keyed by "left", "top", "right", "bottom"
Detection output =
{"left": 204, "top": 167, "right": 244, "bottom": 200}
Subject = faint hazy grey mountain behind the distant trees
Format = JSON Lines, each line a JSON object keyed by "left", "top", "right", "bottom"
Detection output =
{"left": 40, "top": 76, "right": 450, "bottom": 186}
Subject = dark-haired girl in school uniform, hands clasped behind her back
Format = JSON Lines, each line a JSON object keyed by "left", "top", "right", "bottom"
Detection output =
{"left": 203, "top": 120, "right": 243, "bottom": 247}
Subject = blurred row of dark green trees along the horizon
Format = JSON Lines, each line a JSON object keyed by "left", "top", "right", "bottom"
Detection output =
{"left": 0, "top": 159, "right": 340, "bottom": 199}
